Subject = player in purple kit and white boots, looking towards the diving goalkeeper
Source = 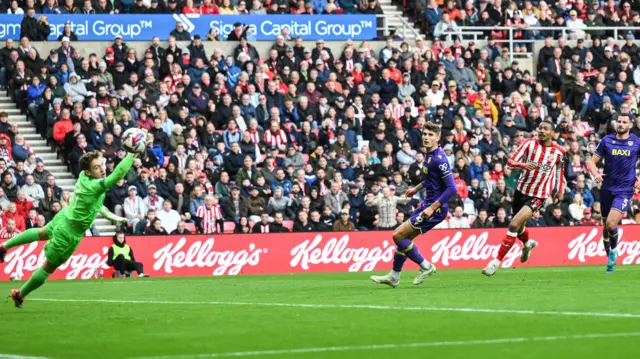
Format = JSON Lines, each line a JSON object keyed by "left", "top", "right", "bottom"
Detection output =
{"left": 371, "top": 123, "right": 456, "bottom": 288}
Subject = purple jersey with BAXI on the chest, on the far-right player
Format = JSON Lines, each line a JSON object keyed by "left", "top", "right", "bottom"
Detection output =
{"left": 596, "top": 134, "right": 640, "bottom": 195}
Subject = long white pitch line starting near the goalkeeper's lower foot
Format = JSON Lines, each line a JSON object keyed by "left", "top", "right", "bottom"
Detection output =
{"left": 29, "top": 298, "right": 640, "bottom": 318}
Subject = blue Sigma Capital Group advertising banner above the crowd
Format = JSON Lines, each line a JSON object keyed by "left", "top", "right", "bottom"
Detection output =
{"left": 0, "top": 14, "right": 376, "bottom": 41}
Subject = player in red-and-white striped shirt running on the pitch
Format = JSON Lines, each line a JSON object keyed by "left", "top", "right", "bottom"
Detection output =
{"left": 482, "top": 121, "right": 565, "bottom": 277}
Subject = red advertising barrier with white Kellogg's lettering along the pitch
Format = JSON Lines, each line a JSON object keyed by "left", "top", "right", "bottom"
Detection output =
{"left": 0, "top": 225, "right": 640, "bottom": 280}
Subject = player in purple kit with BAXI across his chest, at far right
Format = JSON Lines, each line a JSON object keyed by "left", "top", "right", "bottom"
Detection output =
{"left": 587, "top": 114, "right": 640, "bottom": 273}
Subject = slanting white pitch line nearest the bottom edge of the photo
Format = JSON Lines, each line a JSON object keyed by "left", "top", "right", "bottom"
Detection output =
{"left": 127, "top": 332, "right": 640, "bottom": 359}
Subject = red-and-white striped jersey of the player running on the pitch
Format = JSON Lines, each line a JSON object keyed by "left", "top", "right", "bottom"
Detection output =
{"left": 507, "top": 139, "right": 565, "bottom": 199}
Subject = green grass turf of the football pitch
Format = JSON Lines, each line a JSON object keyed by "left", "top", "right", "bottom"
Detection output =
{"left": 0, "top": 266, "right": 640, "bottom": 359}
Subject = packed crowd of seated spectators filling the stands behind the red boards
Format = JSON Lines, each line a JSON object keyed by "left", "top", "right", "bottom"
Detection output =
{"left": 0, "top": 0, "right": 640, "bottom": 234}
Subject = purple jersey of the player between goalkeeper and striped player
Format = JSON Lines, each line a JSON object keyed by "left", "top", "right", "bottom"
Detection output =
{"left": 422, "top": 147, "right": 456, "bottom": 207}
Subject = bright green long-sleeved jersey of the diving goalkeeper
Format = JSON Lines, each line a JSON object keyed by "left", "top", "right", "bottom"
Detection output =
{"left": 65, "top": 155, "right": 135, "bottom": 235}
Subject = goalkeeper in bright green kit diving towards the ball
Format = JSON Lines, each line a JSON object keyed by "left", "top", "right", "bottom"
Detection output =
{"left": 0, "top": 151, "right": 136, "bottom": 308}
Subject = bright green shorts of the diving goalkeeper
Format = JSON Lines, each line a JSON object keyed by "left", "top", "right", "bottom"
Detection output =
{"left": 44, "top": 213, "right": 83, "bottom": 266}
